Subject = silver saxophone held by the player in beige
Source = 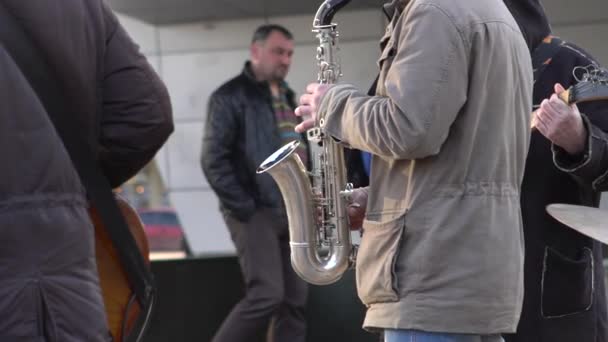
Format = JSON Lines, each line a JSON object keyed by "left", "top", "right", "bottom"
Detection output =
{"left": 257, "top": 0, "right": 356, "bottom": 285}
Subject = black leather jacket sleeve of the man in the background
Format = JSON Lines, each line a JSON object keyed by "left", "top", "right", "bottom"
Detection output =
{"left": 201, "top": 93, "right": 255, "bottom": 221}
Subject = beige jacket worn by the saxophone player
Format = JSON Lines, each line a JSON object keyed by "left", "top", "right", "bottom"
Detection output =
{"left": 319, "top": 0, "right": 532, "bottom": 334}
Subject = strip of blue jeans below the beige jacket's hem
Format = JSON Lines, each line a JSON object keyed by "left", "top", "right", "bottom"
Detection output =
{"left": 384, "top": 329, "right": 504, "bottom": 342}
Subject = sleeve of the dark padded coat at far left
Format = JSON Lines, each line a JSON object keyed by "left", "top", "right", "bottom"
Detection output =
{"left": 99, "top": 5, "right": 173, "bottom": 187}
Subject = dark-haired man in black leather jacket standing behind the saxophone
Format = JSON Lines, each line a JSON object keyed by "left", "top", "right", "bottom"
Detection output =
{"left": 201, "top": 25, "right": 309, "bottom": 342}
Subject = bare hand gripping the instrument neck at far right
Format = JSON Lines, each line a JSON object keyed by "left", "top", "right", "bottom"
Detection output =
{"left": 534, "top": 84, "right": 587, "bottom": 155}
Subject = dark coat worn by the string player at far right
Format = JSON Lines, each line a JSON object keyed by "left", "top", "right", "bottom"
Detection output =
{"left": 506, "top": 40, "right": 608, "bottom": 342}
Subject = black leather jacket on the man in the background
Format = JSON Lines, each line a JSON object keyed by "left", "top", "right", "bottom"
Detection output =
{"left": 201, "top": 62, "right": 306, "bottom": 221}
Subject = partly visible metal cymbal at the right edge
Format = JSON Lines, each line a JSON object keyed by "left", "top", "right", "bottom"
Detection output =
{"left": 547, "top": 203, "right": 608, "bottom": 244}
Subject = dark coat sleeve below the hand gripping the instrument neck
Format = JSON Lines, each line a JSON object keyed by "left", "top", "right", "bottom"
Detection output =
{"left": 552, "top": 101, "right": 608, "bottom": 191}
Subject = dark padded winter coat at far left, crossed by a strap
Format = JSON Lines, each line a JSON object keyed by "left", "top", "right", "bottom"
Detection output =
{"left": 0, "top": 0, "right": 173, "bottom": 342}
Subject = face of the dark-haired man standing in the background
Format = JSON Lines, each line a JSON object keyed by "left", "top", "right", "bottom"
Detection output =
{"left": 251, "top": 31, "right": 294, "bottom": 81}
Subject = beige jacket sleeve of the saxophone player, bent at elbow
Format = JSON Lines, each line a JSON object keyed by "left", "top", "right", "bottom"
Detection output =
{"left": 318, "top": 4, "right": 468, "bottom": 159}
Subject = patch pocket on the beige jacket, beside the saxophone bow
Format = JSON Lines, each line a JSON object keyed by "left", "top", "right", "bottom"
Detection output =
{"left": 356, "top": 216, "right": 405, "bottom": 305}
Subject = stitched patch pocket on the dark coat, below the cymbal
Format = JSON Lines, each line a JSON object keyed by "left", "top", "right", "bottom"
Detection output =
{"left": 541, "top": 247, "right": 594, "bottom": 318}
